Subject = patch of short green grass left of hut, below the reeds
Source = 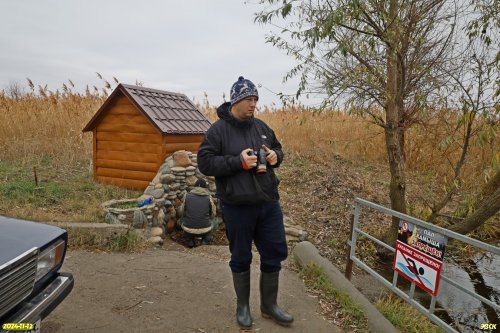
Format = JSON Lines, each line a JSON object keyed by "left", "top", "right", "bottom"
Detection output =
{"left": 0, "top": 158, "right": 142, "bottom": 222}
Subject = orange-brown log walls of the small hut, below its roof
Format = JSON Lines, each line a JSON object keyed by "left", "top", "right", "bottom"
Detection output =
{"left": 93, "top": 95, "right": 204, "bottom": 190}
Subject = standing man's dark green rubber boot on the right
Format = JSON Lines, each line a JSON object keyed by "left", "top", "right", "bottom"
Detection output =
{"left": 260, "top": 271, "right": 293, "bottom": 326}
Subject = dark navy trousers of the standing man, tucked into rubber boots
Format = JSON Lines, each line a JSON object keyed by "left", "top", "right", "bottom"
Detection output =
{"left": 220, "top": 202, "right": 288, "bottom": 273}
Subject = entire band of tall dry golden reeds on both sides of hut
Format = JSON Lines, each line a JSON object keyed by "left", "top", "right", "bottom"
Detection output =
{"left": 0, "top": 81, "right": 500, "bottom": 219}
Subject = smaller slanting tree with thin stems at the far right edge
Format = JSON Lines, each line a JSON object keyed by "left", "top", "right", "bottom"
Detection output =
{"left": 427, "top": 0, "right": 500, "bottom": 234}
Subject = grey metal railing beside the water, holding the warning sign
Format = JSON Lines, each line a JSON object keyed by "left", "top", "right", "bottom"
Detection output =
{"left": 345, "top": 198, "right": 500, "bottom": 333}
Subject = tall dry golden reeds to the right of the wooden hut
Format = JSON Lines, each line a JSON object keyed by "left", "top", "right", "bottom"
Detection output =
{"left": 202, "top": 104, "right": 500, "bottom": 197}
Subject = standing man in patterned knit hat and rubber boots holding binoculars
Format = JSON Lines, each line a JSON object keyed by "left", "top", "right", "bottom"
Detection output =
{"left": 198, "top": 76, "right": 293, "bottom": 329}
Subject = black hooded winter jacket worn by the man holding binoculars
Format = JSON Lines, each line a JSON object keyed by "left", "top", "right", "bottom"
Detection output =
{"left": 198, "top": 103, "right": 283, "bottom": 205}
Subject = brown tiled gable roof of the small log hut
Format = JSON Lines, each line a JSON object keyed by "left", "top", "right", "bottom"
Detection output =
{"left": 83, "top": 83, "right": 211, "bottom": 134}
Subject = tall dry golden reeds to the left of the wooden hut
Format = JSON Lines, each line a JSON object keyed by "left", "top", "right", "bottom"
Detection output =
{"left": 0, "top": 80, "right": 105, "bottom": 165}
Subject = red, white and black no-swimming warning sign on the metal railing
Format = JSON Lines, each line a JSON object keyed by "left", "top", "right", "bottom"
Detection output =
{"left": 393, "top": 221, "right": 447, "bottom": 296}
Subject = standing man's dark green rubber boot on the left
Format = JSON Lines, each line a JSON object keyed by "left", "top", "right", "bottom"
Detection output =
{"left": 233, "top": 271, "right": 253, "bottom": 330}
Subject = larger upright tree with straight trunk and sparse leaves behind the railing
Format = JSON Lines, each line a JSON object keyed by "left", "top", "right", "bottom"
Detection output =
{"left": 256, "top": 0, "right": 456, "bottom": 243}
